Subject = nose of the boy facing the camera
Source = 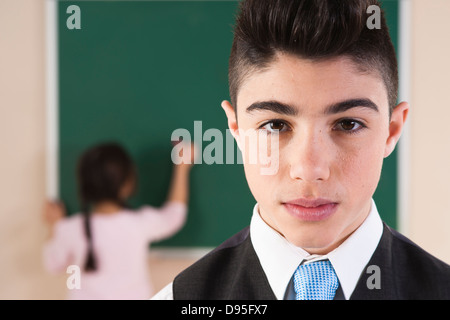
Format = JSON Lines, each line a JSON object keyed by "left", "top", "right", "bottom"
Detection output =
{"left": 289, "top": 131, "right": 331, "bottom": 182}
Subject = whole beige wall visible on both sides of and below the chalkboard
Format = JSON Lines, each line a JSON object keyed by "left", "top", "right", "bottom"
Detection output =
{"left": 0, "top": 0, "right": 450, "bottom": 299}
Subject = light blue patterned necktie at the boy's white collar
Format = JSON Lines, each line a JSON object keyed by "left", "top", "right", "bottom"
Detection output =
{"left": 294, "top": 260, "right": 339, "bottom": 300}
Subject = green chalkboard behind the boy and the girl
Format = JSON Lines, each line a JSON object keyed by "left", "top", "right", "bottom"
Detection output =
{"left": 58, "top": 1, "right": 398, "bottom": 247}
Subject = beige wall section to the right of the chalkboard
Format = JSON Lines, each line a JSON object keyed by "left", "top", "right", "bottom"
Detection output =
{"left": 408, "top": 0, "right": 450, "bottom": 263}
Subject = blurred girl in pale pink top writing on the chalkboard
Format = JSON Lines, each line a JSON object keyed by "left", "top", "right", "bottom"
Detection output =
{"left": 43, "top": 143, "right": 194, "bottom": 300}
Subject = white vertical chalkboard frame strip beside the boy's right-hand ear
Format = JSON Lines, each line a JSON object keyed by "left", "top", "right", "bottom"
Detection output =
{"left": 397, "top": 0, "right": 412, "bottom": 235}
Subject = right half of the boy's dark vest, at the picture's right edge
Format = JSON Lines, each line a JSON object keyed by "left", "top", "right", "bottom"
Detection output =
{"left": 351, "top": 223, "right": 450, "bottom": 300}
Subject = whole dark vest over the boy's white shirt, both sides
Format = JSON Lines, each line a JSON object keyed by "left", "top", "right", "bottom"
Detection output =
{"left": 173, "top": 224, "right": 450, "bottom": 300}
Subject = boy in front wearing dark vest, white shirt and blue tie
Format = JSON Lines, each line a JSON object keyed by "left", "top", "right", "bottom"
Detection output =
{"left": 155, "top": 0, "right": 450, "bottom": 299}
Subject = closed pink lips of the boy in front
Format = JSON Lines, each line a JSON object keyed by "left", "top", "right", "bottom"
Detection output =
{"left": 282, "top": 198, "right": 338, "bottom": 221}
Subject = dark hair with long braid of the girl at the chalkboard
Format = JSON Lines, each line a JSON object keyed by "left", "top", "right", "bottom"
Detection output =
{"left": 77, "top": 143, "right": 136, "bottom": 271}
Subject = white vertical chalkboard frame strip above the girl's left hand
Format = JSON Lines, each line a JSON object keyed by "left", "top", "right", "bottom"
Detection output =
{"left": 45, "top": 0, "right": 59, "bottom": 200}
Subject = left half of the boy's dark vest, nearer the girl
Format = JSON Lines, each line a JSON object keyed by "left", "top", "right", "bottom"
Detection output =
{"left": 173, "top": 227, "right": 275, "bottom": 300}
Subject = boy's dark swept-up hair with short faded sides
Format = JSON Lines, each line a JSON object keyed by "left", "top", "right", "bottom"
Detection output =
{"left": 229, "top": 0, "right": 398, "bottom": 112}
